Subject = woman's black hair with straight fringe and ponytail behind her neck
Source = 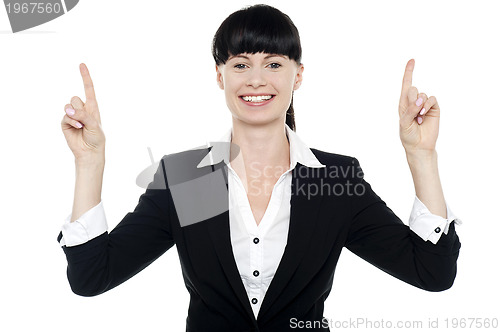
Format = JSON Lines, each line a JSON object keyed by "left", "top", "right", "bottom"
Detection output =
{"left": 212, "top": 5, "right": 302, "bottom": 131}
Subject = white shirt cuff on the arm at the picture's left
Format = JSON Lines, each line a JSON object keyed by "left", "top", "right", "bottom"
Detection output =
{"left": 59, "top": 200, "right": 108, "bottom": 247}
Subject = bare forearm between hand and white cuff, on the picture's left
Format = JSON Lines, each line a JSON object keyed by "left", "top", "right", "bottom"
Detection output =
{"left": 71, "top": 157, "right": 104, "bottom": 222}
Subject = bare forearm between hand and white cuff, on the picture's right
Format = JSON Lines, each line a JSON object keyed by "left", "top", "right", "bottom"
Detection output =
{"left": 406, "top": 150, "right": 447, "bottom": 218}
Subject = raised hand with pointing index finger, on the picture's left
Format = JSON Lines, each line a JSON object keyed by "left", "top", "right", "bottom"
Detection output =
{"left": 61, "top": 63, "right": 106, "bottom": 164}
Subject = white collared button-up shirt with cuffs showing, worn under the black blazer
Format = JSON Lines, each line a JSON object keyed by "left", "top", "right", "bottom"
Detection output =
{"left": 60, "top": 125, "right": 462, "bottom": 318}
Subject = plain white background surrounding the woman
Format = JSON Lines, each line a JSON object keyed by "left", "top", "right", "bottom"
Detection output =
{"left": 0, "top": 0, "right": 500, "bottom": 332}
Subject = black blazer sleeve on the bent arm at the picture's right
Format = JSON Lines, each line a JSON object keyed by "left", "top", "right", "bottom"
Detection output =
{"left": 346, "top": 158, "right": 461, "bottom": 291}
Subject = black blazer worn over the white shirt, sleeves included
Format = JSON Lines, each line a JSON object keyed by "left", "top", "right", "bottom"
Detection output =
{"left": 59, "top": 149, "right": 460, "bottom": 332}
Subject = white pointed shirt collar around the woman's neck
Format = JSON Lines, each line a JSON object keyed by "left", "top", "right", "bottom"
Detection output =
{"left": 196, "top": 124, "right": 326, "bottom": 169}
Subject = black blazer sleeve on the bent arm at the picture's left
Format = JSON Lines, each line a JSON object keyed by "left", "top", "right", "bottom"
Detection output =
{"left": 58, "top": 159, "right": 174, "bottom": 296}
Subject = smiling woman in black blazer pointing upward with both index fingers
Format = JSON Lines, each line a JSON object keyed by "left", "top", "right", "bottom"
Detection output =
{"left": 59, "top": 5, "right": 460, "bottom": 331}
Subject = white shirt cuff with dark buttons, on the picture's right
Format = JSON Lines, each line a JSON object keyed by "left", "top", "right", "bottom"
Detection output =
{"left": 409, "top": 196, "right": 462, "bottom": 244}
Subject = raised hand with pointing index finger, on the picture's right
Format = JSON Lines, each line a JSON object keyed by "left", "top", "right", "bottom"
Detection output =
{"left": 399, "top": 59, "right": 440, "bottom": 154}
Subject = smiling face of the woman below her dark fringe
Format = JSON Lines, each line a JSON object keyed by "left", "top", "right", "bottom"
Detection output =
{"left": 216, "top": 53, "right": 304, "bottom": 125}
